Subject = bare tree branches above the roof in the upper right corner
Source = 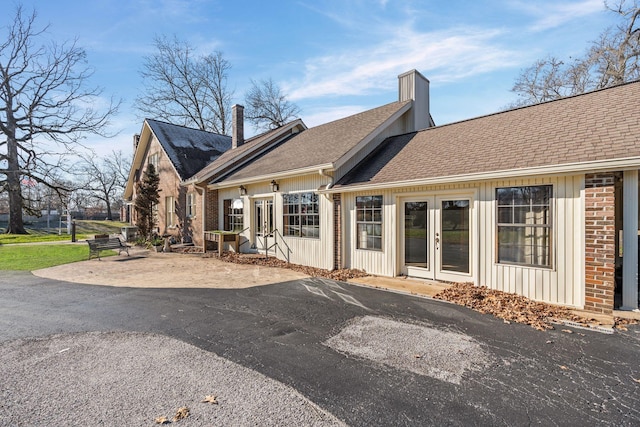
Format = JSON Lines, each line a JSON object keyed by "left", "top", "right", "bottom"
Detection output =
{"left": 509, "top": 0, "right": 640, "bottom": 107}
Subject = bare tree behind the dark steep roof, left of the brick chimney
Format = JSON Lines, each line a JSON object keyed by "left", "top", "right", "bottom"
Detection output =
{"left": 136, "top": 37, "right": 233, "bottom": 135}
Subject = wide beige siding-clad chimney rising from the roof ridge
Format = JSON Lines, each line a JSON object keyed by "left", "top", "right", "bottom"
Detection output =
{"left": 398, "top": 70, "right": 431, "bottom": 132}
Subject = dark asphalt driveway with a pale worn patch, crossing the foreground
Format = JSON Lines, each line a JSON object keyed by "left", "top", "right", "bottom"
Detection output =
{"left": 0, "top": 272, "right": 640, "bottom": 426}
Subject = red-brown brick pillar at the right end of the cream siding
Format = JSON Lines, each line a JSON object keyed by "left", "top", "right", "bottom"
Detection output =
{"left": 584, "top": 173, "right": 616, "bottom": 314}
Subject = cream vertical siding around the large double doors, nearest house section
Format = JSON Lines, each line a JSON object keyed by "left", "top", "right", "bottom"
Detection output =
{"left": 342, "top": 175, "right": 584, "bottom": 307}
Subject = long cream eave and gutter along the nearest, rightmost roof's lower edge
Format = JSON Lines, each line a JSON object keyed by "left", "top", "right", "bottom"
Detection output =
{"left": 320, "top": 156, "right": 640, "bottom": 194}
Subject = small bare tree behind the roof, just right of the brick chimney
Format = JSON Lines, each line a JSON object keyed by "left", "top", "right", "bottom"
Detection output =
{"left": 245, "top": 79, "right": 300, "bottom": 130}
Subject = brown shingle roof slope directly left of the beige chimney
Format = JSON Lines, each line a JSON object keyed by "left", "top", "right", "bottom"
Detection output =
{"left": 218, "top": 101, "right": 411, "bottom": 180}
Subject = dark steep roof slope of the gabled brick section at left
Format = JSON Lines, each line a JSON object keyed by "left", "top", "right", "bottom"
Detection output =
{"left": 147, "top": 119, "right": 231, "bottom": 179}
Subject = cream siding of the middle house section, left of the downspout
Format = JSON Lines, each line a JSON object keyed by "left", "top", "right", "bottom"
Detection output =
{"left": 219, "top": 174, "right": 334, "bottom": 270}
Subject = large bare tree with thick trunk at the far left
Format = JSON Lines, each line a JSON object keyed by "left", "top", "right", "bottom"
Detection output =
{"left": 0, "top": 7, "right": 119, "bottom": 234}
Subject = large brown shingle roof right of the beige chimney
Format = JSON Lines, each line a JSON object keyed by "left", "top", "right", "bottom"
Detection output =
{"left": 335, "top": 82, "right": 640, "bottom": 188}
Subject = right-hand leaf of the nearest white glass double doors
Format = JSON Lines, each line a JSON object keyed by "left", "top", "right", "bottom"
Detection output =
{"left": 433, "top": 197, "right": 472, "bottom": 282}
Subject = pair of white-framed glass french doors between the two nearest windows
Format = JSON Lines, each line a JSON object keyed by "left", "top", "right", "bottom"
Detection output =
{"left": 399, "top": 196, "right": 472, "bottom": 281}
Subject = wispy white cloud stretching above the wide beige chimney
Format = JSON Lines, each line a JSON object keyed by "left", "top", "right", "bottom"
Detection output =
{"left": 284, "top": 25, "right": 521, "bottom": 100}
